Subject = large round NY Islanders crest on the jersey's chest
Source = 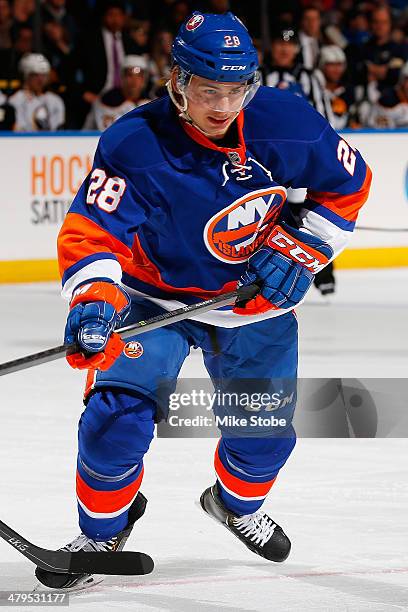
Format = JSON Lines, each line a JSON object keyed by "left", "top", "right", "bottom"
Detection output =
{"left": 204, "top": 187, "right": 286, "bottom": 264}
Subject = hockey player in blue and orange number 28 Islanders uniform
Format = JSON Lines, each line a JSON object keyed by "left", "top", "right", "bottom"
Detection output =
{"left": 36, "top": 12, "right": 371, "bottom": 588}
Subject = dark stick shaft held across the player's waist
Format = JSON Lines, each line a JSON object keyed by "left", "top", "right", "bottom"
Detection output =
{"left": 0, "top": 285, "right": 259, "bottom": 376}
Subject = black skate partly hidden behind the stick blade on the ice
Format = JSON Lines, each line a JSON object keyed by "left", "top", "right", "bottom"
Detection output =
{"left": 35, "top": 491, "right": 147, "bottom": 590}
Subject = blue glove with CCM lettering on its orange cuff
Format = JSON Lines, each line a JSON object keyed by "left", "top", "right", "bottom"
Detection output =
{"left": 234, "top": 221, "right": 333, "bottom": 315}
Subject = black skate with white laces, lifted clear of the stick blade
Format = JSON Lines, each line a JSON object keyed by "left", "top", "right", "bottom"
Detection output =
{"left": 200, "top": 484, "right": 291, "bottom": 562}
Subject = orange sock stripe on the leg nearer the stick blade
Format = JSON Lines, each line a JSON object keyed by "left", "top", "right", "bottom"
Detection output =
{"left": 76, "top": 468, "right": 144, "bottom": 514}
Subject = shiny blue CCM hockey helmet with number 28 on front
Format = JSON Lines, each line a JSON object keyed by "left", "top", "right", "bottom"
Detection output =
{"left": 172, "top": 11, "right": 258, "bottom": 82}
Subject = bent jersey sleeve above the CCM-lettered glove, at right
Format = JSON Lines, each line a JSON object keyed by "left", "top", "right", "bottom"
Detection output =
{"left": 290, "top": 124, "right": 372, "bottom": 257}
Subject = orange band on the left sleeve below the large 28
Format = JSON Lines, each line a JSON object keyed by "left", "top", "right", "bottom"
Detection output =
{"left": 58, "top": 213, "right": 132, "bottom": 277}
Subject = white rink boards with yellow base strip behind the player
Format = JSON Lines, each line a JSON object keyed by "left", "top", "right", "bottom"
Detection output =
{"left": 0, "top": 130, "right": 408, "bottom": 282}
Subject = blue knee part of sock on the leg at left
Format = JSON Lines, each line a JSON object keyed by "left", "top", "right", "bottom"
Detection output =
{"left": 78, "top": 389, "right": 155, "bottom": 476}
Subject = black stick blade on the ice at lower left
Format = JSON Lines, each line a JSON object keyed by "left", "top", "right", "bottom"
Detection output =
{"left": 0, "top": 521, "right": 154, "bottom": 576}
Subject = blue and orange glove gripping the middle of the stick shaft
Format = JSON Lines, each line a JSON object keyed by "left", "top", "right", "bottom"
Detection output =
{"left": 64, "top": 281, "right": 130, "bottom": 370}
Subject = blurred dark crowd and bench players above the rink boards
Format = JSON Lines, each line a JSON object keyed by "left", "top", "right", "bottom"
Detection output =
{"left": 0, "top": 0, "right": 408, "bottom": 131}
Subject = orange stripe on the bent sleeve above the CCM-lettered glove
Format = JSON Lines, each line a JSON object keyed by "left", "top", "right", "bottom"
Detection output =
{"left": 307, "top": 166, "right": 372, "bottom": 221}
